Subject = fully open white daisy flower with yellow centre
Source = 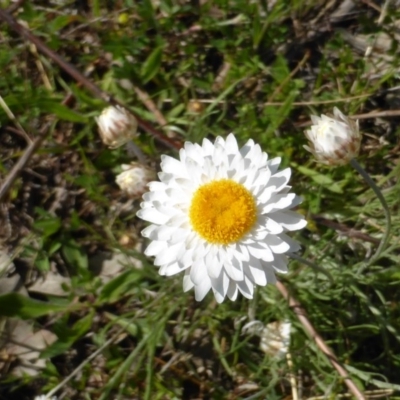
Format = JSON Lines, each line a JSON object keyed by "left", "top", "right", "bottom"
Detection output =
{"left": 137, "top": 134, "right": 307, "bottom": 303}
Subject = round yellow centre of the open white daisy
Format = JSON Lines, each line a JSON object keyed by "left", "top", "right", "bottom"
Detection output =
{"left": 189, "top": 179, "right": 257, "bottom": 245}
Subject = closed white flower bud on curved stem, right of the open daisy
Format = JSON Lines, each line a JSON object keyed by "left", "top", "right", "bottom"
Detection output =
{"left": 304, "top": 107, "right": 361, "bottom": 165}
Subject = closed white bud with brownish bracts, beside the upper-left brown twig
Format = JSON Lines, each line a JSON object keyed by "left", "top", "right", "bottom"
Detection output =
{"left": 96, "top": 106, "right": 137, "bottom": 149}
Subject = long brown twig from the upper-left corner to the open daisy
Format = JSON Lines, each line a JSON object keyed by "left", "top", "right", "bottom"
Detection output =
{"left": 0, "top": 9, "right": 180, "bottom": 153}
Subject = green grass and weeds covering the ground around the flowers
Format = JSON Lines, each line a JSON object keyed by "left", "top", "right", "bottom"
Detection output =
{"left": 0, "top": 0, "right": 400, "bottom": 400}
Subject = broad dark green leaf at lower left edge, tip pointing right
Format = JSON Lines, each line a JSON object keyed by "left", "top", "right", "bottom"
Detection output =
{"left": 0, "top": 293, "right": 68, "bottom": 319}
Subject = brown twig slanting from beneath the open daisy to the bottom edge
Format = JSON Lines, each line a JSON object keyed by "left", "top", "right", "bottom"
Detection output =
{"left": 276, "top": 281, "right": 365, "bottom": 400}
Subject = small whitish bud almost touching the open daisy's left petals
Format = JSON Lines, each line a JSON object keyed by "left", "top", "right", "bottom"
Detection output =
{"left": 115, "top": 162, "right": 156, "bottom": 197}
